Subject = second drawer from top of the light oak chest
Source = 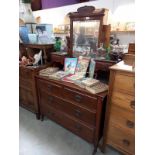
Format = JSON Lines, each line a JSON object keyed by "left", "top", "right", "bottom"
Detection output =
{"left": 111, "top": 91, "right": 135, "bottom": 112}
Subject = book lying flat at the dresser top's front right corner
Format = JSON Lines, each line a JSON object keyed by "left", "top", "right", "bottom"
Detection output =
{"left": 85, "top": 82, "right": 108, "bottom": 94}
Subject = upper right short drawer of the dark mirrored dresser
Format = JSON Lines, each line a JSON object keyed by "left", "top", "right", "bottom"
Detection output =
{"left": 63, "top": 88, "right": 97, "bottom": 110}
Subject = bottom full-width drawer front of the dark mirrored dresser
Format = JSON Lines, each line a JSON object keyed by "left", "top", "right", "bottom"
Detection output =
{"left": 41, "top": 105, "right": 94, "bottom": 143}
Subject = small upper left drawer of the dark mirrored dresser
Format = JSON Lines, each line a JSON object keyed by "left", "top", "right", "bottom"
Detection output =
{"left": 38, "top": 80, "right": 62, "bottom": 96}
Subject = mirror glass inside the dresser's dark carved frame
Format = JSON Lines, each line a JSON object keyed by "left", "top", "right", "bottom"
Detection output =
{"left": 72, "top": 20, "right": 100, "bottom": 57}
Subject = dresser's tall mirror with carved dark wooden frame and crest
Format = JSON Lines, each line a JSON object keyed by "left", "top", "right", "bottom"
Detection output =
{"left": 69, "top": 6, "right": 110, "bottom": 57}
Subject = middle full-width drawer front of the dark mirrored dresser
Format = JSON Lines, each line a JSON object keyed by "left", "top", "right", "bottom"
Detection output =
{"left": 40, "top": 91, "right": 96, "bottom": 126}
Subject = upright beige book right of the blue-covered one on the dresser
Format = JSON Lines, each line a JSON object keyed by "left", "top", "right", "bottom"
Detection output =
{"left": 75, "top": 56, "right": 90, "bottom": 76}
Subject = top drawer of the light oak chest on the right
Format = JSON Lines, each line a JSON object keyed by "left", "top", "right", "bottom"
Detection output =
{"left": 113, "top": 72, "right": 135, "bottom": 95}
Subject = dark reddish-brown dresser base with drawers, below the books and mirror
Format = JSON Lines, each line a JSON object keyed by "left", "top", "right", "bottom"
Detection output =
{"left": 36, "top": 75, "right": 107, "bottom": 153}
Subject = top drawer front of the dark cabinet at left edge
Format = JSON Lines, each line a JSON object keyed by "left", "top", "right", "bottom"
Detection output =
{"left": 19, "top": 67, "right": 33, "bottom": 79}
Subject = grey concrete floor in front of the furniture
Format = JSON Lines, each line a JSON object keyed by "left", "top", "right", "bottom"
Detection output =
{"left": 19, "top": 107, "right": 120, "bottom": 155}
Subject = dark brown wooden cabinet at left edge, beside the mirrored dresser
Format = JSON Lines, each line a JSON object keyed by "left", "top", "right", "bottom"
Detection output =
{"left": 19, "top": 66, "right": 45, "bottom": 118}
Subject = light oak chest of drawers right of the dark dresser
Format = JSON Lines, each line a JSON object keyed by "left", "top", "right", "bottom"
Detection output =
{"left": 102, "top": 61, "right": 135, "bottom": 155}
